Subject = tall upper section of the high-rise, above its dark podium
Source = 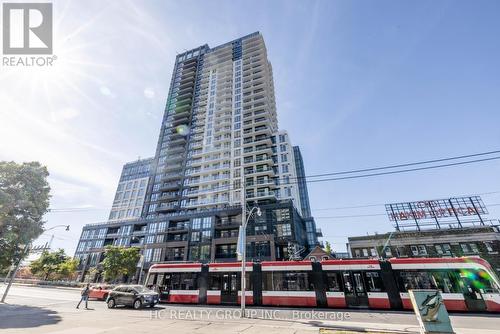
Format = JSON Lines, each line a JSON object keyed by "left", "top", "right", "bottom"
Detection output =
{"left": 144, "top": 33, "right": 288, "bottom": 217}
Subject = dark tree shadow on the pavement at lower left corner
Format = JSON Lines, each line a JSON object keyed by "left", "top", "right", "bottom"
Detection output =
{"left": 0, "top": 304, "right": 61, "bottom": 329}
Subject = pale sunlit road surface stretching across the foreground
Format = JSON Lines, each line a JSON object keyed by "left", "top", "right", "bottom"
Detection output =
{"left": 0, "top": 284, "right": 500, "bottom": 334}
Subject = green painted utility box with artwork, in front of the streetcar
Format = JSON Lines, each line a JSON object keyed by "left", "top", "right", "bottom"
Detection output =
{"left": 408, "top": 290, "right": 454, "bottom": 333}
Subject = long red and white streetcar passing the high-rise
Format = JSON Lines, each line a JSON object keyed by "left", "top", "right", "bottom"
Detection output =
{"left": 146, "top": 257, "right": 500, "bottom": 312}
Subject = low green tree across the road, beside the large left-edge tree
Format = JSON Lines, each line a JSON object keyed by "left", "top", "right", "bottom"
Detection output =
{"left": 30, "top": 249, "right": 78, "bottom": 280}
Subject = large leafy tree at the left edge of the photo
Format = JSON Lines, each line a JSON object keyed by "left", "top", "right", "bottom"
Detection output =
{"left": 0, "top": 161, "right": 50, "bottom": 272}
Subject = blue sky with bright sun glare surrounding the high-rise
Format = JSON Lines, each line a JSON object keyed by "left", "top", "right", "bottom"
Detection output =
{"left": 0, "top": 0, "right": 500, "bottom": 254}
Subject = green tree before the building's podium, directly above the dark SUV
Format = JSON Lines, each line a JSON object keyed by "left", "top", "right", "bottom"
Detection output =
{"left": 101, "top": 246, "right": 140, "bottom": 282}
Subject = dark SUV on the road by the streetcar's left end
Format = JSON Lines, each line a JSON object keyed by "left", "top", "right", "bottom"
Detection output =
{"left": 106, "top": 285, "right": 159, "bottom": 309}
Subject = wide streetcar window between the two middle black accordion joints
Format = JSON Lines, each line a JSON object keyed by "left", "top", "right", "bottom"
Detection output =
{"left": 262, "top": 271, "right": 314, "bottom": 291}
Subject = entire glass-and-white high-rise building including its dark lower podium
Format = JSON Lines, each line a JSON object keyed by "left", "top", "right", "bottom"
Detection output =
{"left": 75, "top": 32, "right": 318, "bottom": 277}
